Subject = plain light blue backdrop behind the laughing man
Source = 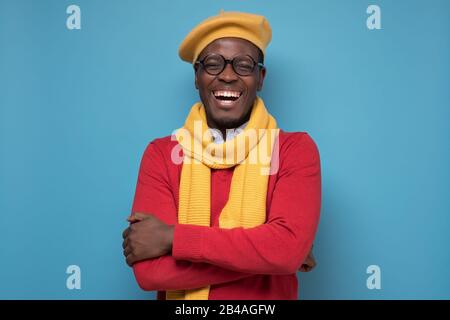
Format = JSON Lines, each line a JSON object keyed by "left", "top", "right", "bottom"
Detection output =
{"left": 0, "top": 0, "right": 450, "bottom": 299}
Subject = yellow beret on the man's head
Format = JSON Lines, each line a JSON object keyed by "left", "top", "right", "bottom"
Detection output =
{"left": 178, "top": 11, "right": 272, "bottom": 63}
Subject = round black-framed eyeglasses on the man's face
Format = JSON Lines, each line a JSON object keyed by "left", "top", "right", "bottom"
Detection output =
{"left": 195, "top": 54, "right": 264, "bottom": 76}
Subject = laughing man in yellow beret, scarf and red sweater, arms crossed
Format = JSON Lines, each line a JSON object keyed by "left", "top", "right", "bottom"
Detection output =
{"left": 123, "top": 12, "right": 321, "bottom": 300}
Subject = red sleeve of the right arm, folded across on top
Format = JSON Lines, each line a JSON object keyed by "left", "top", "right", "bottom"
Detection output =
{"left": 172, "top": 132, "right": 321, "bottom": 274}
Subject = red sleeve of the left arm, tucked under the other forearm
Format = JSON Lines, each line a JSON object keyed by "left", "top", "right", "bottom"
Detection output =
{"left": 132, "top": 141, "right": 252, "bottom": 291}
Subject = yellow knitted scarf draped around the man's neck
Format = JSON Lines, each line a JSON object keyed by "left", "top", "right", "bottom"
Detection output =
{"left": 166, "top": 97, "right": 279, "bottom": 300}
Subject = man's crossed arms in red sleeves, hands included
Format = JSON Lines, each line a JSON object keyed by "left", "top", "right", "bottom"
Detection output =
{"left": 123, "top": 134, "right": 321, "bottom": 290}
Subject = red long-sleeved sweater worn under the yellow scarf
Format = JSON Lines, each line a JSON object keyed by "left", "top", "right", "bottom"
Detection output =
{"left": 132, "top": 130, "right": 321, "bottom": 300}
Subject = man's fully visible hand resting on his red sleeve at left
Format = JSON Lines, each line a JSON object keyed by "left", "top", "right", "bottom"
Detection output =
{"left": 122, "top": 212, "right": 174, "bottom": 267}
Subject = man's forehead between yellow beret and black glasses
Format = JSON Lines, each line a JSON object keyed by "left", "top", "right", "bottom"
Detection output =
{"left": 199, "top": 38, "right": 258, "bottom": 60}
